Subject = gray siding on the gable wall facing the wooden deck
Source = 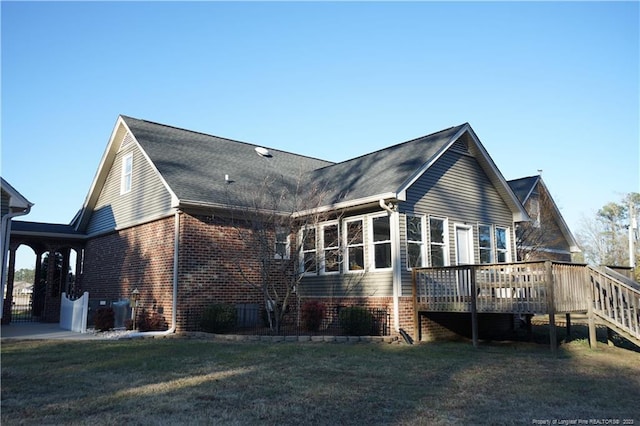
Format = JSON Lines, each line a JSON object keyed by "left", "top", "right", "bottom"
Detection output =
{"left": 400, "top": 150, "right": 516, "bottom": 295}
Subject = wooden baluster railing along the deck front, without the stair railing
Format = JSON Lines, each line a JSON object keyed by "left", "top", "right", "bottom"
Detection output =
{"left": 413, "top": 262, "right": 588, "bottom": 314}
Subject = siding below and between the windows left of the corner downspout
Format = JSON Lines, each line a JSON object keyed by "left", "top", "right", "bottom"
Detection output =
{"left": 299, "top": 211, "right": 393, "bottom": 297}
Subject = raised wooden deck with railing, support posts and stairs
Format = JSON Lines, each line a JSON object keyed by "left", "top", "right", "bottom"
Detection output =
{"left": 413, "top": 261, "right": 640, "bottom": 352}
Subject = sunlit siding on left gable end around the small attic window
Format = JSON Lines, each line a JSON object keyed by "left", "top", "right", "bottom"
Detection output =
{"left": 87, "top": 134, "right": 171, "bottom": 235}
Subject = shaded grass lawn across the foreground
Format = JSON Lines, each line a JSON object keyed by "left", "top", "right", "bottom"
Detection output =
{"left": 1, "top": 338, "right": 640, "bottom": 425}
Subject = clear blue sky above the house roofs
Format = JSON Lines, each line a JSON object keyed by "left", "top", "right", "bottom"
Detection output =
{"left": 0, "top": 1, "right": 640, "bottom": 267}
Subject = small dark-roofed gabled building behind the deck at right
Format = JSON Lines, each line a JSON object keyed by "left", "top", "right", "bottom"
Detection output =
{"left": 509, "top": 176, "right": 580, "bottom": 262}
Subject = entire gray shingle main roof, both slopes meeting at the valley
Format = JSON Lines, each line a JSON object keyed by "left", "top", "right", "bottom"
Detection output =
{"left": 122, "top": 116, "right": 464, "bottom": 211}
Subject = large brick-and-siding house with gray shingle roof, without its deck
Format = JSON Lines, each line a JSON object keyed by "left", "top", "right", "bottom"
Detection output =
{"left": 1, "top": 116, "right": 577, "bottom": 340}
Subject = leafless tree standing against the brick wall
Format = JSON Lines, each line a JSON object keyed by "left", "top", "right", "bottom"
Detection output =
{"left": 222, "top": 174, "right": 336, "bottom": 332}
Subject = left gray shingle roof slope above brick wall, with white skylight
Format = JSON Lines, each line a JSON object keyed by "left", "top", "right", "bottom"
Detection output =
{"left": 123, "top": 116, "right": 333, "bottom": 211}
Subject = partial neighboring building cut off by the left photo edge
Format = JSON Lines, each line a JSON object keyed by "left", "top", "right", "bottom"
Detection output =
{"left": 0, "top": 177, "right": 33, "bottom": 317}
